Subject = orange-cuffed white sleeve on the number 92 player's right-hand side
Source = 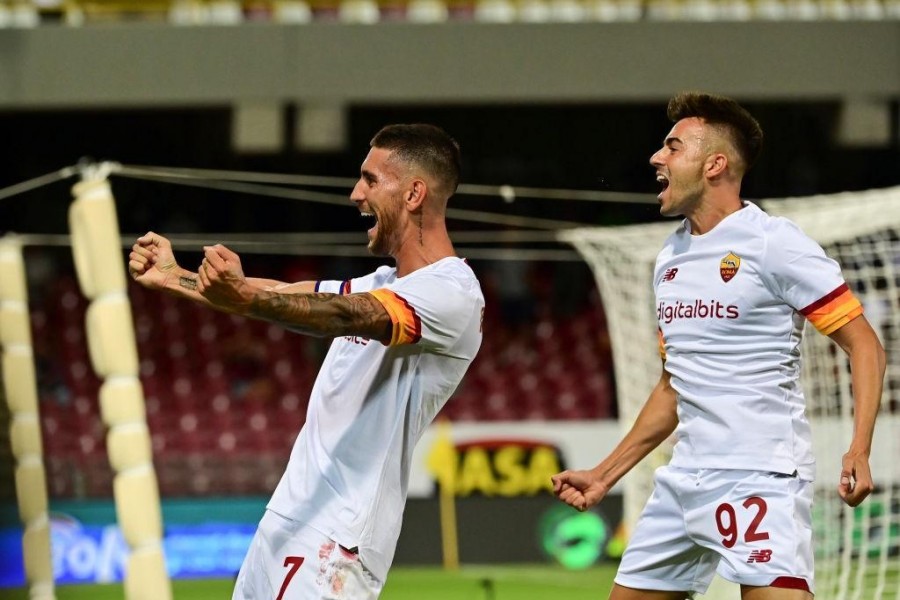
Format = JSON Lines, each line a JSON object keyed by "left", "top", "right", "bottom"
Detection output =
{"left": 766, "top": 219, "right": 863, "bottom": 335}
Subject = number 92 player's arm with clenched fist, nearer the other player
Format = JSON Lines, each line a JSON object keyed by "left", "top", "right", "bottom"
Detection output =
{"left": 552, "top": 363, "right": 678, "bottom": 510}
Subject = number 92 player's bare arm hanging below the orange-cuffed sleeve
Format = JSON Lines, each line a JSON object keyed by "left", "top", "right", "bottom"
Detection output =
{"left": 829, "top": 316, "right": 885, "bottom": 506}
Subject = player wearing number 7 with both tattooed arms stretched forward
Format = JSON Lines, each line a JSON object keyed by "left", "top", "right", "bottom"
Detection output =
{"left": 129, "top": 124, "right": 484, "bottom": 600}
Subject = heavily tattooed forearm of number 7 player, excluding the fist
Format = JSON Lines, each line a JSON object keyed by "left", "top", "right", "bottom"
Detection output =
{"left": 250, "top": 292, "right": 392, "bottom": 340}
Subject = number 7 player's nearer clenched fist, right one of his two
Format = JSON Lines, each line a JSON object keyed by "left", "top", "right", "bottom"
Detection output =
{"left": 197, "top": 244, "right": 254, "bottom": 312}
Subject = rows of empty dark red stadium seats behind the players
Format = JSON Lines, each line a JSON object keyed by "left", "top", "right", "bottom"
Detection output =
{"left": 22, "top": 264, "right": 615, "bottom": 498}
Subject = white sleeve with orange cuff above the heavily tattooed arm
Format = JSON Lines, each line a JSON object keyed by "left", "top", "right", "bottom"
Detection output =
{"left": 369, "top": 275, "right": 484, "bottom": 351}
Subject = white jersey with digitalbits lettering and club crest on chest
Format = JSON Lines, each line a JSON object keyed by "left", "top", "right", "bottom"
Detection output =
{"left": 653, "top": 203, "right": 862, "bottom": 480}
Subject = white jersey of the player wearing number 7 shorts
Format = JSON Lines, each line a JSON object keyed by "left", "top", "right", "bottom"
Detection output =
{"left": 268, "top": 257, "right": 484, "bottom": 581}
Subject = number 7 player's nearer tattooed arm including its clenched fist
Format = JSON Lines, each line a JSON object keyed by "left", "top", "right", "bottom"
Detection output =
{"left": 197, "top": 245, "right": 393, "bottom": 343}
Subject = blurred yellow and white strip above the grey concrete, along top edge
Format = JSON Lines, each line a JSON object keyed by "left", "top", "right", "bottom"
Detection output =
{"left": 0, "top": 0, "right": 900, "bottom": 27}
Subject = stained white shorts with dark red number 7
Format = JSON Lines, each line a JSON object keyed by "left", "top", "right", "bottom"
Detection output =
{"left": 232, "top": 510, "right": 384, "bottom": 600}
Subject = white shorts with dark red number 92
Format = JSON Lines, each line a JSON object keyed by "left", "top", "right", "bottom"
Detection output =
{"left": 616, "top": 466, "right": 814, "bottom": 594}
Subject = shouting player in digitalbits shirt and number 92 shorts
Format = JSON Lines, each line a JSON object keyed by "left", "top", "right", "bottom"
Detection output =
{"left": 553, "top": 93, "right": 885, "bottom": 600}
